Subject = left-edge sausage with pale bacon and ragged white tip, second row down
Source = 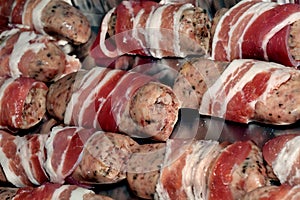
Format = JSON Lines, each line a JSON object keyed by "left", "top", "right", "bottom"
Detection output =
{"left": 0, "top": 28, "right": 81, "bottom": 82}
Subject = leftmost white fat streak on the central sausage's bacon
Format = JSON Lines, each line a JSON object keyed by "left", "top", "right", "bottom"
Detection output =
{"left": 64, "top": 67, "right": 105, "bottom": 124}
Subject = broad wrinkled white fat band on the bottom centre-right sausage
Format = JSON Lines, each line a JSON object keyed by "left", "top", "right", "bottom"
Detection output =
{"left": 182, "top": 140, "right": 219, "bottom": 200}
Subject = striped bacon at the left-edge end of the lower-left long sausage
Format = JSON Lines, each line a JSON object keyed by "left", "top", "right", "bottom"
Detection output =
{"left": 0, "top": 131, "right": 47, "bottom": 187}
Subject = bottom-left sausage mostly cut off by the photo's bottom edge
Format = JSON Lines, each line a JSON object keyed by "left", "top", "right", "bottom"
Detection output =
{"left": 9, "top": 183, "right": 112, "bottom": 200}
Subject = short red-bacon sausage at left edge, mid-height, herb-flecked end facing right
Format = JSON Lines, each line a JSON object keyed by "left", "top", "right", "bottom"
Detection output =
{"left": 0, "top": 77, "right": 48, "bottom": 131}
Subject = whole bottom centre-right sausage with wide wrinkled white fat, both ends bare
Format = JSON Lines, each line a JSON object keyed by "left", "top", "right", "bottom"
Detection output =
{"left": 127, "top": 139, "right": 269, "bottom": 199}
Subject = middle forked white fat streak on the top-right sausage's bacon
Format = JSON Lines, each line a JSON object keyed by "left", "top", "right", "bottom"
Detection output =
{"left": 227, "top": 2, "right": 277, "bottom": 60}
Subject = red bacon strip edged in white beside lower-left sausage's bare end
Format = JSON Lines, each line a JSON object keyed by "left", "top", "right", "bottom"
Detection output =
{"left": 44, "top": 127, "right": 94, "bottom": 183}
